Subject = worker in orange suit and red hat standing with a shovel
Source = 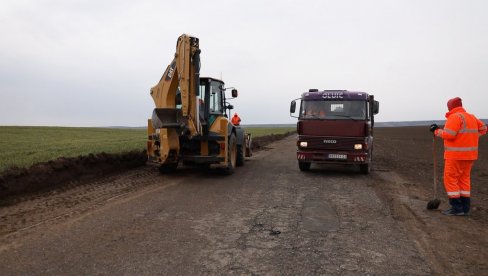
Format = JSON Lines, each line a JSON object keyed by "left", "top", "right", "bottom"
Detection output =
{"left": 430, "top": 97, "right": 486, "bottom": 216}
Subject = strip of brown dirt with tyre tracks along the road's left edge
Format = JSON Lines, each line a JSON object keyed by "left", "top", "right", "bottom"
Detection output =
{"left": 0, "top": 167, "right": 164, "bottom": 250}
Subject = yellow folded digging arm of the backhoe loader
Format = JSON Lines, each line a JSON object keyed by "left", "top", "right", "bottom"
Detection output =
{"left": 148, "top": 34, "right": 202, "bottom": 164}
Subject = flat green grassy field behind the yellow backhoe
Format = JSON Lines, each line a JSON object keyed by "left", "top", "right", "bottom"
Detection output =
{"left": 0, "top": 126, "right": 294, "bottom": 172}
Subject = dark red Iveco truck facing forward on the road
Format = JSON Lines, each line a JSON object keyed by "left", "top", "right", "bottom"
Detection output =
{"left": 290, "top": 89, "right": 379, "bottom": 174}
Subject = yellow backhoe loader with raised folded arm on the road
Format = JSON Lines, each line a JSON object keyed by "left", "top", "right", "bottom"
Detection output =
{"left": 147, "top": 34, "right": 251, "bottom": 174}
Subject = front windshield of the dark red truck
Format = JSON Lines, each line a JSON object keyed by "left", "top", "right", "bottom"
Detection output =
{"left": 300, "top": 100, "right": 367, "bottom": 120}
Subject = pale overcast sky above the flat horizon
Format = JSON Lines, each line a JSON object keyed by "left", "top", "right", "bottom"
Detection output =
{"left": 0, "top": 0, "right": 488, "bottom": 126}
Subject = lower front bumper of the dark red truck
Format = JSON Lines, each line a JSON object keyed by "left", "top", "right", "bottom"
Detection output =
{"left": 297, "top": 151, "right": 370, "bottom": 164}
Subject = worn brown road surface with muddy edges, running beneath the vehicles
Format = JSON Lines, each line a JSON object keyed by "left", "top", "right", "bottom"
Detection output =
{"left": 0, "top": 133, "right": 488, "bottom": 275}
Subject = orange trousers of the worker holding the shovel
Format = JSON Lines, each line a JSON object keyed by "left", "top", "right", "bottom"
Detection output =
{"left": 444, "top": 159, "right": 474, "bottom": 198}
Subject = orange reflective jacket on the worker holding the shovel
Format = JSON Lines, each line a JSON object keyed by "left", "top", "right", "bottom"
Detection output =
{"left": 435, "top": 107, "right": 486, "bottom": 160}
